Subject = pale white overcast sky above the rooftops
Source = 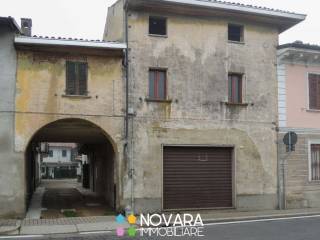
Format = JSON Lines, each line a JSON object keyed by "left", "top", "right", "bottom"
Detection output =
{"left": 0, "top": 0, "right": 320, "bottom": 44}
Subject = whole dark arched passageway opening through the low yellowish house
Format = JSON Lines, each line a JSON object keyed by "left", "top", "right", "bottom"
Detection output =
{"left": 25, "top": 119, "right": 117, "bottom": 218}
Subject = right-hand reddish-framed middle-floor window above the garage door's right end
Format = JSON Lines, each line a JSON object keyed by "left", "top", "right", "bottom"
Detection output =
{"left": 228, "top": 73, "right": 242, "bottom": 103}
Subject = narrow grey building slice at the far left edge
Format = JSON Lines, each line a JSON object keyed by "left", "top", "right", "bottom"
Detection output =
{"left": 0, "top": 17, "right": 23, "bottom": 217}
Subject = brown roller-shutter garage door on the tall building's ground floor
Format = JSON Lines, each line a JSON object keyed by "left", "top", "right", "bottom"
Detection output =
{"left": 163, "top": 147, "right": 232, "bottom": 209}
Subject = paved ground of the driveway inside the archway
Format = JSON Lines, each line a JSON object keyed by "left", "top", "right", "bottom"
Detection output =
{"left": 27, "top": 179, "right": 114, "bottom": 219}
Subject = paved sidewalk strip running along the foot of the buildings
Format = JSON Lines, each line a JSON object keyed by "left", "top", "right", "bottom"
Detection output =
{"left": 0, "top": 208, "right": 320, "bottom": 235}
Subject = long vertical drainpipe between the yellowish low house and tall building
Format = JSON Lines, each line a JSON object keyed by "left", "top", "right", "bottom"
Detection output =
{"left": 124, "top": 0, "right": 134, "bottom": 213}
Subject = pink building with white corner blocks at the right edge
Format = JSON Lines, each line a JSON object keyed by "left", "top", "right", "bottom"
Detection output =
{"left": 278, "top": 41, "right": 320, "bottom": 208}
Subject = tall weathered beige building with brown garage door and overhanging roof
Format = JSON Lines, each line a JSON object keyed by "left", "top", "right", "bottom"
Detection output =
{"left": 104, "top": 0, "right": 305, "bottom": 212}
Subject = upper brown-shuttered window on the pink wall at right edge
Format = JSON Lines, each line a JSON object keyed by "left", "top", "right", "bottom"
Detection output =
{"left": 309, "top": 74, "right": 320, "bottom": 110}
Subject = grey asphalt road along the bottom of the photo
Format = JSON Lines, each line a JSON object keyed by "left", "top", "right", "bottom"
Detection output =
{"left": 0, "top": 216, "right": 320, "bottom": 240}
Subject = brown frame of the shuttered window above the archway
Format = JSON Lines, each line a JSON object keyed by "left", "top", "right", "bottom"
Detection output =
{"left": 65, "top": 60, "right": 89, "bottom": 97}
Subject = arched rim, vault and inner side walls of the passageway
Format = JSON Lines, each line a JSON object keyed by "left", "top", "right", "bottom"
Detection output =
{"left": 24, "top": 117, "right": 119, "bottom": 215}
